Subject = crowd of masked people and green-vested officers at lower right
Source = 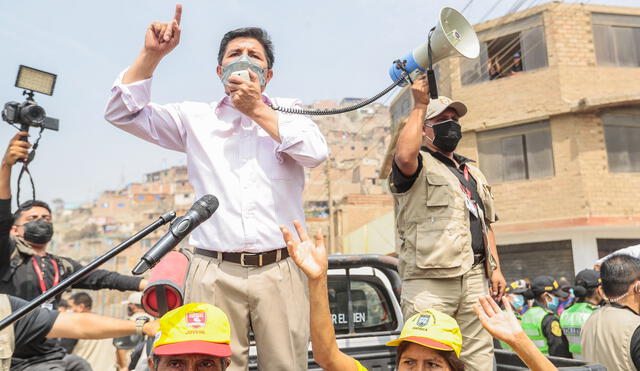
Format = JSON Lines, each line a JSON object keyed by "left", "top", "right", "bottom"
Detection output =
{"left": 501, "top": 245, "right": 640, "bottom": 369}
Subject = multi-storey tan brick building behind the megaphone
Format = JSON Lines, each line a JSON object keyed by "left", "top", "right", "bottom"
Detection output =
{"left": 381, "top": 2, "right": 640, "bottom": 279}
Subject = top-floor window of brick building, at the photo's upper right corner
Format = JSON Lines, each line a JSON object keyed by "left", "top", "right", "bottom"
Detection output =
{"left": 591, "top": 13, "right": 640, "bottom": 67}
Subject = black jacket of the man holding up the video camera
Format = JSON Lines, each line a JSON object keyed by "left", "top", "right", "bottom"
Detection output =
{"left": 0, "top": 199, "right": 142, "bottom": 306}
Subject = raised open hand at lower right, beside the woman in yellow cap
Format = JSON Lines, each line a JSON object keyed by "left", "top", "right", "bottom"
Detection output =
{"left": 473, "top": 296, "right": 524, "bottom": 345}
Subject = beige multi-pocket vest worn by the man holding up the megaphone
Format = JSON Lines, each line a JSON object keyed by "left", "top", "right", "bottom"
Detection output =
{"left": 390, "top": 151, "right": 496, "bottom": 280}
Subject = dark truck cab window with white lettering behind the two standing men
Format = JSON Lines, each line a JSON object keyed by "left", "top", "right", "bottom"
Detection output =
{"left": 329, "top": 275, "right": 397, "bottom": 334}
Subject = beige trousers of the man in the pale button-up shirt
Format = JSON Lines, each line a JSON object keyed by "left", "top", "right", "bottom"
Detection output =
{"left": 185, "top": 254, "right": 309, "bottom": 371}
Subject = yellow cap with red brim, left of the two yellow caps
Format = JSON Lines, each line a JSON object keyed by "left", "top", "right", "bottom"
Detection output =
{"left": 153, "top": 303, "right": 231, "bottom": 357}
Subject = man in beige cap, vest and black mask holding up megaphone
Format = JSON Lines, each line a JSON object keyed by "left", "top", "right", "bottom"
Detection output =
{"left": 390, "top": 76, "right": 506, "bottom": 370}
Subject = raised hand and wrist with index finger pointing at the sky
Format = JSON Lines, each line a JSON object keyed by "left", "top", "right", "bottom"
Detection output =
{"left": 122, "top": 4, "right": 182, "bottom": 84}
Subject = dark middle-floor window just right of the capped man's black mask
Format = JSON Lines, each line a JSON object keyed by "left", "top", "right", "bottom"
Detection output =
{"left": 477, "top": 120, "right": 554, "bottom": 183}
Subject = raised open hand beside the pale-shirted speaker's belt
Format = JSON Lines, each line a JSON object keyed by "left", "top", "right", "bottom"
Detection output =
{"left": 280, "top": 221, "right": 328, "bottom": 280}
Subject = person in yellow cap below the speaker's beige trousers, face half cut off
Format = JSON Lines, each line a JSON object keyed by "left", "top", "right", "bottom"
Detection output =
{"left": 149, "top": 303, "right": 231, "bottom": 371}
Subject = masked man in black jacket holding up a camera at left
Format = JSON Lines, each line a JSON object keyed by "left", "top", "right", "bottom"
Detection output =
{"left": 0, "top": 132, "right": 147, "bottom": 308}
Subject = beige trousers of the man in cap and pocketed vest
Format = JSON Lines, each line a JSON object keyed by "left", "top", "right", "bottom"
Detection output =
{"left": 402, "top": 264, "right": 493, "bottom": 371}
